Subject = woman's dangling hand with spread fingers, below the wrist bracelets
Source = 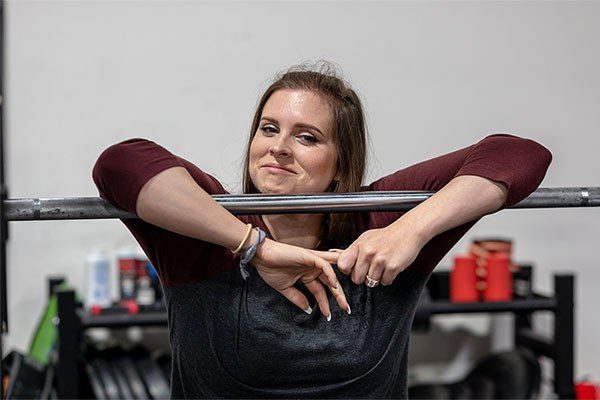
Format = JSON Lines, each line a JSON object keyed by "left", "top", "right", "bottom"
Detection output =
{"left": 252, "top": 239, "right": 350, "bottom": 321}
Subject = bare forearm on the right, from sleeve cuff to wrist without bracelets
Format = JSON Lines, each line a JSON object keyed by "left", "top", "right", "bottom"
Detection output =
{"left": 390, "top": 175, "right": 507, "bottom": 245}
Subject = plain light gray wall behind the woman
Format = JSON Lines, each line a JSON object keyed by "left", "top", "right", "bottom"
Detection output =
{"left": 5, "top": 1, "right": 600, "bottom": 379}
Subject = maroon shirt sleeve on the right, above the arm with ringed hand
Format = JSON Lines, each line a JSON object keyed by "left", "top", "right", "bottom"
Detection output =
{"left": 365, "top": 134, "right": 552, "bottom": 273}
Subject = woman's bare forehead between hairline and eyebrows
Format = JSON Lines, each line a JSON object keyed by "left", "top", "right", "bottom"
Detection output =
{"left": 261, "top": 89, "right": 333, "bottom": 132}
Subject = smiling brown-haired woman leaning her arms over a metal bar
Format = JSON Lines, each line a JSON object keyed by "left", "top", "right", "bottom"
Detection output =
{"left": 94, "top": 67, "right": 551, "bottom": 398}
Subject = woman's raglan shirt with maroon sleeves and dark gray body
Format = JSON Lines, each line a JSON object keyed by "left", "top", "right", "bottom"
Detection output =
{"left": 93, "top": 135, "right": 552, "bottom": 398}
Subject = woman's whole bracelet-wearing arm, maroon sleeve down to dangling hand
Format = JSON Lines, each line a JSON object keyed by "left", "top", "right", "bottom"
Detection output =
{"left": 94, "top": 139, "right": 348, "bottom": 315}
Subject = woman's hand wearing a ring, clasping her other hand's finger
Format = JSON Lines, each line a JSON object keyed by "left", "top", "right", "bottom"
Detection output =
{"left": 337, "top": 218, "right": 427, "bottom": 285}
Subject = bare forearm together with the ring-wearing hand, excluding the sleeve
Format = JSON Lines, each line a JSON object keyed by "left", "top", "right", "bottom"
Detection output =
{"left": 338, "top": 176, "right": 507, "bottom": 285}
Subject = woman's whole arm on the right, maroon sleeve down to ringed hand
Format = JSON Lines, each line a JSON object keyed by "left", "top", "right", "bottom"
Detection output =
{"left": 338, "top": 135, "right": 551, "bottom": 285}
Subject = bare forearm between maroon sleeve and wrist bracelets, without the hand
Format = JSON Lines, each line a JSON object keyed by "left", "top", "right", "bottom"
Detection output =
{"left": 136, "top": 167, "right": 247, "bottom": 250}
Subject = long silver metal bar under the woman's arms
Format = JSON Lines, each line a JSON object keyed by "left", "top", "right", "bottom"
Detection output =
{"left": 5, "top": 187, "right": 600, "bottom": 221}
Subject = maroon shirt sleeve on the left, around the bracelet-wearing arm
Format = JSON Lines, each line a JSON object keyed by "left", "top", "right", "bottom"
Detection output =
{"left": 92, "top": 139, "right": 232, "bottom": 285}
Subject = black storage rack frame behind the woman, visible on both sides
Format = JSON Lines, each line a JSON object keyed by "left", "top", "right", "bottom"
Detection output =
{"left": 50, "top": 266, "right": 575, "bottom": 399}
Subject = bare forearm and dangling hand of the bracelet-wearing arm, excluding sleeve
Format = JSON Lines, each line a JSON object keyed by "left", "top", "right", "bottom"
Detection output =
{"left": 136, "top": 167, "right": 348, "bottom": 316}
